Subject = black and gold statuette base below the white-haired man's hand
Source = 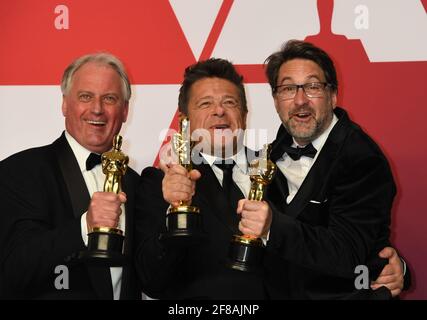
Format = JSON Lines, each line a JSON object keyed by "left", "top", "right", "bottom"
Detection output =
{"left": 79, "top": 227, "right": 126, "bottom": 267}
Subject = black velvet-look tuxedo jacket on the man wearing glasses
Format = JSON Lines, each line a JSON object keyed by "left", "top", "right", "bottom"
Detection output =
{"left": 264, "top": 107, "right": 396, "bottom": 299}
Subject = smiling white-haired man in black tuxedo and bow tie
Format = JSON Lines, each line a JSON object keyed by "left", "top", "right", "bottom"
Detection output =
{"left": 0, "top": 53, "right": 141, "bottom": 299}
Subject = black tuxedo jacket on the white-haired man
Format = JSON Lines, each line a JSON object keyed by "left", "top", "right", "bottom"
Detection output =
{"left": 0, "top": 134, "right": 141, "bottom": 299}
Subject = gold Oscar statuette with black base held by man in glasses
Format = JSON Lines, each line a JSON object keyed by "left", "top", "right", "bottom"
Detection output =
{"left": 228, "top": 144, "right": 277, "bottom": 271}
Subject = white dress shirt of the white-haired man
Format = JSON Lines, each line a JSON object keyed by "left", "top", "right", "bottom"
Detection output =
{"left": 65, "top": 131, "right": 126, "bottom": 300}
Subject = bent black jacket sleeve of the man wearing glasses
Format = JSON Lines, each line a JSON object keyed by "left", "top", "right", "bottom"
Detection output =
{"left": 268, "top": 153, "right": 395, "bottom": 278}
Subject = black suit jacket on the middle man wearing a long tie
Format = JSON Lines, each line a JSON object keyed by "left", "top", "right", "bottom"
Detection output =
{"left": 135, "top": 155, "right": 265, "bottom": 300}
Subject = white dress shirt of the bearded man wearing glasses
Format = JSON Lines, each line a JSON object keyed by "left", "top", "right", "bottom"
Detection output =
{"left": 276, "top": 114, "right": 338, "bottom": 204}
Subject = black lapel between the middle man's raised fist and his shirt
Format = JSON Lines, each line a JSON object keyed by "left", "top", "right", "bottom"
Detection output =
{"left": 194, "top": 164, "right": 240, "bottom": 234}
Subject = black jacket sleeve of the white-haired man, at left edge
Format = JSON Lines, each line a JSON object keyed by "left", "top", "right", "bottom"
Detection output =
{"left": 0, "top": 157, "right": 84, "bottom": 296}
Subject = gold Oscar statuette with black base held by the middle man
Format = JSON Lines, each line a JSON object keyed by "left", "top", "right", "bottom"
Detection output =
{"left": 161, "top": 115, "right": 204, "bottom": 246}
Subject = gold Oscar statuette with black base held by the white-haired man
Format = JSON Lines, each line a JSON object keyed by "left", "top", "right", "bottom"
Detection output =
{"left": 81, "top": 135, "right": 129, "bottom": 266}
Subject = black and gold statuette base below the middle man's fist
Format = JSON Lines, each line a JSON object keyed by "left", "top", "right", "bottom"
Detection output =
{"left": 160, "top": 206, "right": 205, "bottom": 246}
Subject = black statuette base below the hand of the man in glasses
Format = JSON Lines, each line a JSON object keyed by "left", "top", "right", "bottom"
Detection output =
{"left": 227, "top": 235, "right": 264, "bottom": 272}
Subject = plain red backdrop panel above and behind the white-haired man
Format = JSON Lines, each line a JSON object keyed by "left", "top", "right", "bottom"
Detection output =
{"left": 0, "top": 0, "right": 194, "bottom": 85}
